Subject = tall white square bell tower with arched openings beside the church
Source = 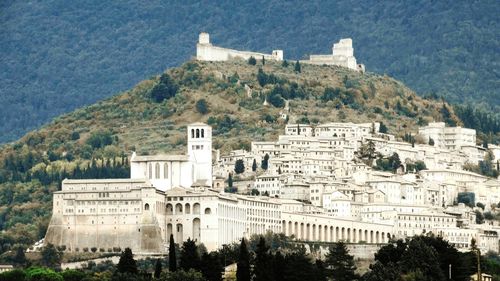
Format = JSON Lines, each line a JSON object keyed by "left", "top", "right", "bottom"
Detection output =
{"left": 187, "top": 123, "right": 212, "bottom": 186}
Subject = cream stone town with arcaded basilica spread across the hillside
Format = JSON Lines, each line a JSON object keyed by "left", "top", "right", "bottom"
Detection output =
{"left": 45, "top": 119, "right": 500, "bottom": 254}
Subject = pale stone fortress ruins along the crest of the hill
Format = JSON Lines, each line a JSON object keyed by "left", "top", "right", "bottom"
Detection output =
{"left": 196, "top": 32, "right": 365, "bottom": 72}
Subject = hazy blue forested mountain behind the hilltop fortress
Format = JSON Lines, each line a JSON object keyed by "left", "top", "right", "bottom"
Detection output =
{"left": 0, "top": 0, "right": 500, "bottom": 142}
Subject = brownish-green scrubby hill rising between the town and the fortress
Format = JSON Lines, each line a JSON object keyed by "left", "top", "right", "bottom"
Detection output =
{"left": 0, "top": 60, "right": 461, "bottom": 249}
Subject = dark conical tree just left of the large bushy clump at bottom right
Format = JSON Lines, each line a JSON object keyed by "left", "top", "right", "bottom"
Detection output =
{"left": 325, "top": 242, "right": 358, "bottom": 281}
